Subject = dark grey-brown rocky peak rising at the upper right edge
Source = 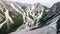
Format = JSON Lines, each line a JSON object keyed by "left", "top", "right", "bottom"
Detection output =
{"left": 46, "top": 2, "right": 60, "bottom": 18}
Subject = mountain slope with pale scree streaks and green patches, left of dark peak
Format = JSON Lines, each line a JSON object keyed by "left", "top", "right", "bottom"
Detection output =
{"left": 0, "top": 1, "right": 49, "bottom": 34}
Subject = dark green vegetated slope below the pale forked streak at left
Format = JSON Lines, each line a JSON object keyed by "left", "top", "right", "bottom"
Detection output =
{"left": 0, "top": 12, "right": 23, "bottom": 34}
